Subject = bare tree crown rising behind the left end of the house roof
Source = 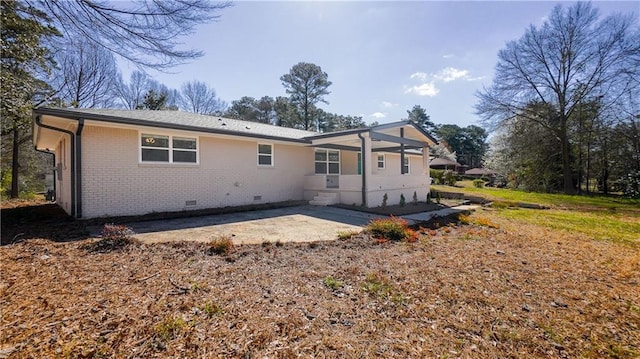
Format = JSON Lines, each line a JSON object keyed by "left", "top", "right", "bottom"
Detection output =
{"left": 53, "top": 40, "right": 120, "bottom": 108}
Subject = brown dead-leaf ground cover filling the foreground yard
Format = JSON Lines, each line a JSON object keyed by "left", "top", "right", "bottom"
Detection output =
{"left": 0, "top": 202, "right": 640, "bottom": 358}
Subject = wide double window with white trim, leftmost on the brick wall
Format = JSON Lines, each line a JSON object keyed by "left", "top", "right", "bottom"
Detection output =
{"left": 140, "top": 133, "right": 198, "bottom": 163}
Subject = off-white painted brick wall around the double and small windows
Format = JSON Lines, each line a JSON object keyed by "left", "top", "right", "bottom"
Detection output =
{"left": 79, "top": 126, "right": 313, "bottom": 218}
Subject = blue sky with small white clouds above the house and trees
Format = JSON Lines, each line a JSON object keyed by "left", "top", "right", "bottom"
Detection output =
{"left": 138, "top": 1, "right": 640, "bottom": 126}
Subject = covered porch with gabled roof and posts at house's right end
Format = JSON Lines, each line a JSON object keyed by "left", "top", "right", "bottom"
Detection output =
{"left": 304, "top": 121, "right": 436, "bottom": 207}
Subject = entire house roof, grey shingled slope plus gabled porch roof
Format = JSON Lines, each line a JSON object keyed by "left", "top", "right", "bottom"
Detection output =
{"left": 33, "top": 107, "right": 437, "bottom": 152}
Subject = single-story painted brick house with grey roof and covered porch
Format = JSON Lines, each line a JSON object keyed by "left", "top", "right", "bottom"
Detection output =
{"left": 33, "top": 107, "right": 436, "bottom": 218}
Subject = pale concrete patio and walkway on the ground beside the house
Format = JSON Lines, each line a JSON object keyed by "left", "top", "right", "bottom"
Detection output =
{"left": 129, "top": 205, "right": 477, "bottom": 244}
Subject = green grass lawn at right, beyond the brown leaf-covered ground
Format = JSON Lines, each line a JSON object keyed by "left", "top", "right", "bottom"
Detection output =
{"left": 433, "top": 181, "right": 640, "bottom": 246}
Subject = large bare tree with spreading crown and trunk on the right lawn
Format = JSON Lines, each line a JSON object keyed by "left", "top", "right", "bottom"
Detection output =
{"left": 476, "top": 2, "right": 640, "bottom": 193}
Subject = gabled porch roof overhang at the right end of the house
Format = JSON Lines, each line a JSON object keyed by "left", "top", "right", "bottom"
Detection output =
{"left": 307, "top": 121, "right": 438, "bottom": 152}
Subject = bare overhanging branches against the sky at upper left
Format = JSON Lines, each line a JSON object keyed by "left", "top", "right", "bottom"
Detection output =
{"left": 26, "top": 0, "right": 231, "bottom": 69}
